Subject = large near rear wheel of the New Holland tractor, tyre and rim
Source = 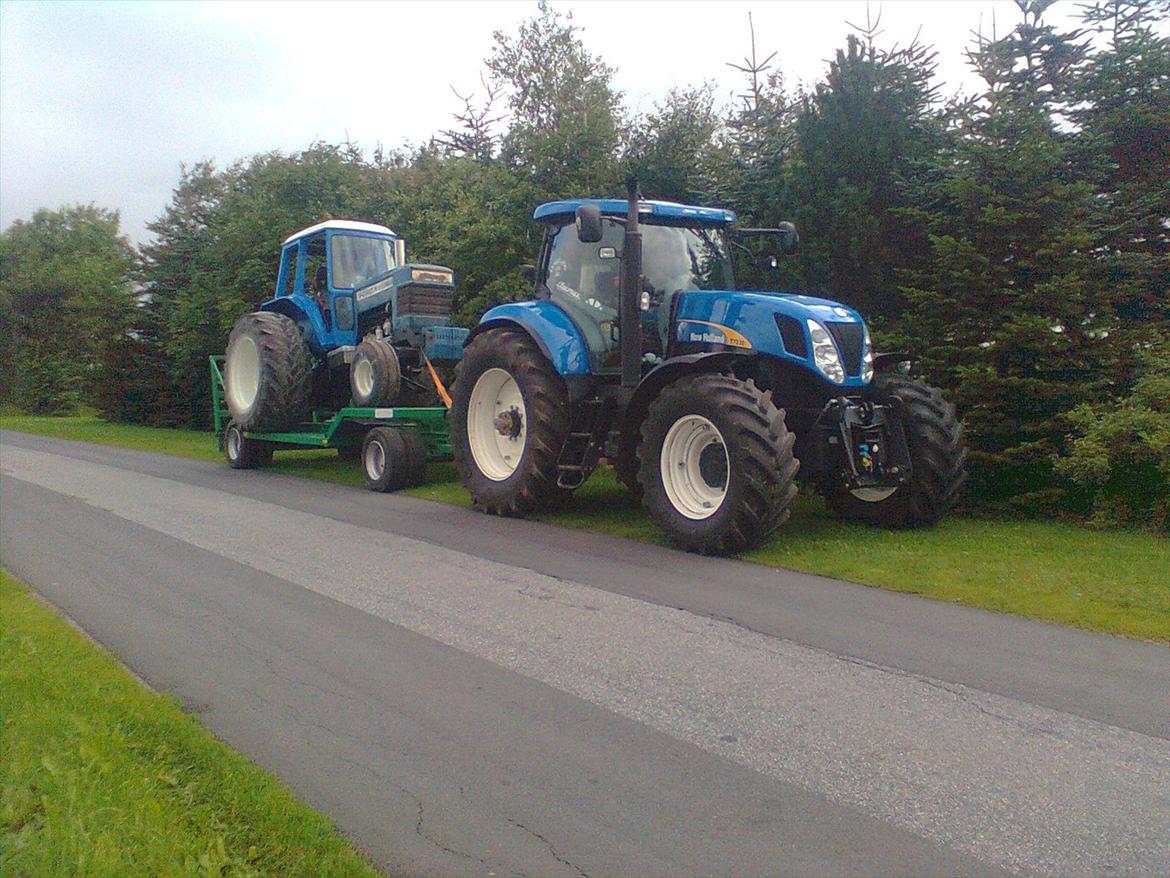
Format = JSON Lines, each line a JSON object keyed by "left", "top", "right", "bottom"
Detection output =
{"left": 448, "top": 329, "right": 569, "bottom": 516}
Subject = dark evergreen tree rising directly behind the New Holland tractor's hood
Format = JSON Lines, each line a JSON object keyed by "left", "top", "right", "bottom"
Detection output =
{"left": 784, "top": 22, "right": 942, "bottom": 323}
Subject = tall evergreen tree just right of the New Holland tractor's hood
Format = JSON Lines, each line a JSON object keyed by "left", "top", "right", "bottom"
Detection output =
{"left": 897, "top": 0, "right": 1099, "bottom": 508}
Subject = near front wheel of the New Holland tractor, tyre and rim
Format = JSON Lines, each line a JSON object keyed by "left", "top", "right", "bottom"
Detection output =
{"left": 639, "top": 373, "right": 798, "bottom": 555}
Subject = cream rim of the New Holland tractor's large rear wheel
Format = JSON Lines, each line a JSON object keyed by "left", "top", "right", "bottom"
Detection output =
{"left": 467, "top": 369, "right": 528, "bottom": 481}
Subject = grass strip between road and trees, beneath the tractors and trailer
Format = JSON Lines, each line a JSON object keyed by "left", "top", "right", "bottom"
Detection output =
{"left": 0, "top": 417, "right": 1170, "bottom": 640}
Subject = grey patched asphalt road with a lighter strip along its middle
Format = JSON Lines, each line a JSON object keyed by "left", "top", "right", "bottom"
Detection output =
{"left": 0, "top": 432, "right": 1170, "bottom": 876}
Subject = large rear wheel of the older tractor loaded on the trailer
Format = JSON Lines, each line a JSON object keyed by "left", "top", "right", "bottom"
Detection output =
{"left": 223, "top": 311, "right": 312, "bottom": 432}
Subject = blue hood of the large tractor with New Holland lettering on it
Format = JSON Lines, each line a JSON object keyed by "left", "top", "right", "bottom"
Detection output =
{"left": 674, "top": 290, "right": 873, "bottom": 387}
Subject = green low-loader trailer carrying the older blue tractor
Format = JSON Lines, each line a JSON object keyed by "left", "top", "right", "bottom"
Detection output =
{"left": 208, "top": 355, "right": 452, "bottom": 491}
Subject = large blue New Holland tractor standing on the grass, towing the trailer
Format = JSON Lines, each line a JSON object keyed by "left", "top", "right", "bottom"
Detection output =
{"left": 449, "top": 184, "right": 966, "bottom": 554}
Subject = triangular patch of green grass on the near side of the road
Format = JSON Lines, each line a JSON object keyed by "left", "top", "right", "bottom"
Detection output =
{"left": 0, "top": 570, "right": 377, "bottom": 878}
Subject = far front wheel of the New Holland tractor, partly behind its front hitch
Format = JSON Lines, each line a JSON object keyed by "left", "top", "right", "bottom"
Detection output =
{"left": 825, "top": 375, "right": 966, "bottom": 528}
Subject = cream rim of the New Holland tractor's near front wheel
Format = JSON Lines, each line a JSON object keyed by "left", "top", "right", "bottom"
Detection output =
{"left": 659, "top": 414, "right": 731, "bottom": 521}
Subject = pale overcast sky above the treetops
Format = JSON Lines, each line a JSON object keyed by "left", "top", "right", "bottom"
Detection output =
{"left": 0, "top": 0, "right": 1076, "bottom": 248}
